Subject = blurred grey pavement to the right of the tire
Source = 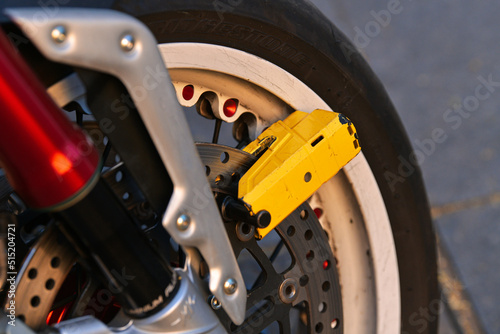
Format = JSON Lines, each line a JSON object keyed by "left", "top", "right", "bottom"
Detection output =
{"left": 313, "top": 0, "right": 500, "bottom": 334}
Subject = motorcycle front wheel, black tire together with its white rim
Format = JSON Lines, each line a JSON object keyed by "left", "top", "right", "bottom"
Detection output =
{"left": 108, "top": 0, "right": 439, "bottom": 334}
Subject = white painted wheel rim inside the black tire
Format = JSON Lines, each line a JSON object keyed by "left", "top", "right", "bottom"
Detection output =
{"left": 159, "top": 43, "right": 401, "bottom": 334}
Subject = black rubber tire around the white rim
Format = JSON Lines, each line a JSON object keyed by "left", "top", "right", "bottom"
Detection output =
{"left": 114, "top": 0, "right": 439, "bottom": 333}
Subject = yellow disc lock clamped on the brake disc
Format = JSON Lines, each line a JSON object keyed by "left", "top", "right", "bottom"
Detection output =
{"left": 238, "top": 109, "right": 361, "bottom": 239}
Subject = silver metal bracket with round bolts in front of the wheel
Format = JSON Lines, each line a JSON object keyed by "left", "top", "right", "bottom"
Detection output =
{"left": 6, "top": 8, "right": 246, "bottom": 324}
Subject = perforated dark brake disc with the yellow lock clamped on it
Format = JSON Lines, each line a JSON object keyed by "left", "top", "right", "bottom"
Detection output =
{"left": 197, "top": 144, "right": 343, "bottom": 333}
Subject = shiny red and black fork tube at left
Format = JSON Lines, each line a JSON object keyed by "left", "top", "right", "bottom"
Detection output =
{"left": 0, "top": 24, "right": 177, "bottom": 317}
